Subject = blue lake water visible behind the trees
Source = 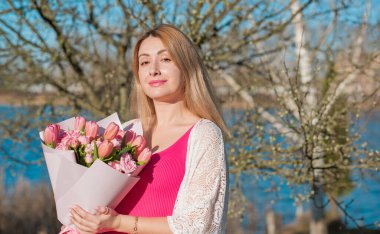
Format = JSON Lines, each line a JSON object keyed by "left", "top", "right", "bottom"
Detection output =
{"left": 0, "top": 106, "right": 380, "bottom": 233}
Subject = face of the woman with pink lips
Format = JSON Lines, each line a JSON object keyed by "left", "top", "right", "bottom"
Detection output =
{"left": 138, "top": 37, "right": 184, "bottom": 103}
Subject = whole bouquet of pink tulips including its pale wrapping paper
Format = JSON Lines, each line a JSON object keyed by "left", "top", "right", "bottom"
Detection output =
{"left": 40, "top": 113, "right": 151, "bottom": 229}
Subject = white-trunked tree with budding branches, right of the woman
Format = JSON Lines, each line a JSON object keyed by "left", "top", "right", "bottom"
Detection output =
{"left": 226, "top": 1, "right": 380, "bottom": 233}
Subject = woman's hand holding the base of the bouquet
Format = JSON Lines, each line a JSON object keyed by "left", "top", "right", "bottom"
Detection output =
{"left": 70, "top": 205, "right": 120, "bottom": 233}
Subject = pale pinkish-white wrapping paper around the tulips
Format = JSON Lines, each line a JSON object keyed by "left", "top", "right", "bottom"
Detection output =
{"left": 40, "top": 113, "right": 142, "bottom": 227}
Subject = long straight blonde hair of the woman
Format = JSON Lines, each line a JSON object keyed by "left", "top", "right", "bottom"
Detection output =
{"left": 132, "top": 24, "right": 228, "bottom": 134}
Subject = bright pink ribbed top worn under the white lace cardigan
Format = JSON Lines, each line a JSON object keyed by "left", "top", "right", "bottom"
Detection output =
{"left": 116, "top": 125, "right": 194, "bottom": 217}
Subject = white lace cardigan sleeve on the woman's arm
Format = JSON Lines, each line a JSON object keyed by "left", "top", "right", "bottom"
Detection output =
{"left": 168, "top": 120, "right": 227, "bottom": 233}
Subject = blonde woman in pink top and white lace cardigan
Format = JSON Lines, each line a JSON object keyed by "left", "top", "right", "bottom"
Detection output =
{"left": 71, "top": 25, "right": 228, "bottom": 234}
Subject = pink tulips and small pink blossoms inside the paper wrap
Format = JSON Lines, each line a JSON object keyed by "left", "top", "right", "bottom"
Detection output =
{"left": 43, "top": 116, "right": 151, "bottom": 174}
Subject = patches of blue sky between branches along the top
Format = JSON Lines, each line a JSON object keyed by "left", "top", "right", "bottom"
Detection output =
{"left": 0, "top": 0, "right": 380, "bottom": 66}
